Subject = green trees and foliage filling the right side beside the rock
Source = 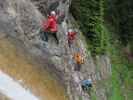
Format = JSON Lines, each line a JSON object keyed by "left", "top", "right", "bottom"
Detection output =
{"left": 70, "top": 0, "right": 133, "bottom": 100}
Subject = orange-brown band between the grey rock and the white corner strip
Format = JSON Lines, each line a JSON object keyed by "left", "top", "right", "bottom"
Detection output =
{"left": 0, "top": 39, "right": 67, "bottom": 100}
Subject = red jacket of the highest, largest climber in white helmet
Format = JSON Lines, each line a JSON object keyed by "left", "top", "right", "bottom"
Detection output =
{"left": 43, "top": 16, "right": 58, "bottom": 32}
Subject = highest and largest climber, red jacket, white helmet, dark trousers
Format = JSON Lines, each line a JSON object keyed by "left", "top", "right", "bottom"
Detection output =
{"left": 42, "top": 11, "right": 59, "bottom": 44}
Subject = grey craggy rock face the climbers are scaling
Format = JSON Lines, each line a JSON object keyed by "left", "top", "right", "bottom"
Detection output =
{"left": 0, "top": 0, "right": 111, "bottom": 100}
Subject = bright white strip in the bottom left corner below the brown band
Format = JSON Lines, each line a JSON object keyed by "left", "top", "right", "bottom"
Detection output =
{"left": 0, "top": 71, "right": 39, "bottom": 100}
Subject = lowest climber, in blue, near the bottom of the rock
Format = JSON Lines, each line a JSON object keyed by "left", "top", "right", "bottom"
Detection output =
{"left": 81, "top": 79, "right": 92, "bottom": 91}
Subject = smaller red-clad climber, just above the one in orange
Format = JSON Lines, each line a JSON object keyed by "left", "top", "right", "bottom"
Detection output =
{"left": 67, "top": 29, "right": 76, "bottom": 47}
